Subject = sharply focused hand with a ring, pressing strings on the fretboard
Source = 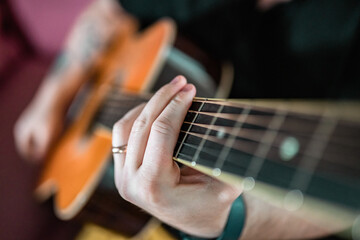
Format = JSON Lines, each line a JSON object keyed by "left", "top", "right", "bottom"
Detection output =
{"left": 113, "top": 77, "right": 241, "bottom": 237}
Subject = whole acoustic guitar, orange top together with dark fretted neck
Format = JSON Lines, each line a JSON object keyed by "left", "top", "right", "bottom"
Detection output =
{"left": 36, "top": 16, "right": 360, "bottom": 239}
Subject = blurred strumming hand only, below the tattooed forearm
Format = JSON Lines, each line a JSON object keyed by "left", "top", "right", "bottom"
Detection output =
{"left": 14, "top": 98, "right": 64, "bottom": 162}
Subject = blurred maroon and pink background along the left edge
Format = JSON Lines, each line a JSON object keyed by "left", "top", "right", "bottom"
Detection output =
{"left": 0, "top": 0, "right": 90, "bottom": 240}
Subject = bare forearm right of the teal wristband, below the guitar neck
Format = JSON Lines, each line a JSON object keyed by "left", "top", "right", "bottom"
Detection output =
{"left": 240, "top": 193, "right": 331, "bottom": 240}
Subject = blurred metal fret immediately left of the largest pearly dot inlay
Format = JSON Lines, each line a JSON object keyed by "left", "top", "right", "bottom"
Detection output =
{"left": 245, "top": 110, "right": 286, "bottom": 178}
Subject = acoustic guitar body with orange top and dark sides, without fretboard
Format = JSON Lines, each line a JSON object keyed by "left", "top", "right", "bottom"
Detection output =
{"left": 35, "top": 15, "right": 232, "bottom": 238}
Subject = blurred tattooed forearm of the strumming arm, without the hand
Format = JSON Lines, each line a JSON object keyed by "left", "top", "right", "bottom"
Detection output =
{"left": 34, "top": 0, "right": 122, "bottom": 111}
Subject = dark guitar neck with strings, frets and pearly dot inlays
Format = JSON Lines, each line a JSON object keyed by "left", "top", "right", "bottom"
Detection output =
{"left": 95, "top": 93, "right": 360, "bottom": 212}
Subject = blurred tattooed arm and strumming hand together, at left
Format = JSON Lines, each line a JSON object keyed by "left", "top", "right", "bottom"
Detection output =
{"left": 14, "top": 0, "right": 126, "bottom": 162}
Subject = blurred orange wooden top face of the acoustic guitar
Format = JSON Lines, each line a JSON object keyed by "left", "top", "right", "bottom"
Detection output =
{"left": 35, "top": 19, "right": 175, "bottom": 219}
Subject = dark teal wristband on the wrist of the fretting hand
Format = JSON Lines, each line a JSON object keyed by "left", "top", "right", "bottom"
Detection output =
{"left": 179, "top": 196, "right": 246, "bottom": 240}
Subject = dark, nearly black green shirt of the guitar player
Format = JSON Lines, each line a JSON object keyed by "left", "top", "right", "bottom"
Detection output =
{"left": 121, "top": 0, "right": 360, "bottom": 98}
